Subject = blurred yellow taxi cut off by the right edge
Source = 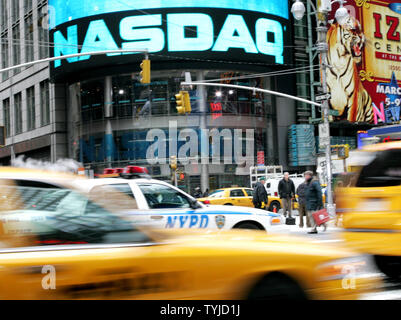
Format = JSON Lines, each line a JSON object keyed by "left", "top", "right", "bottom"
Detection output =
{"left": 336, "top": 142, "right": 401, "bottom": 278}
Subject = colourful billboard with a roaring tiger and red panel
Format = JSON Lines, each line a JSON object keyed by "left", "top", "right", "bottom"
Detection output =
{"left": 327, "top": 0, "right": 401, "bottom": 124}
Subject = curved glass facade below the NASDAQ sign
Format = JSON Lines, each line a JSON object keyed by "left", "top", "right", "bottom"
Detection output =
{"left": 69, "top": 70, "right": 277, "bottom": 191}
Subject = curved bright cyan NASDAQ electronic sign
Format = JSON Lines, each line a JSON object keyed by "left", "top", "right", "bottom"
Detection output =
{"left": 49, "top": 0, "right": 291, "bottom": 79}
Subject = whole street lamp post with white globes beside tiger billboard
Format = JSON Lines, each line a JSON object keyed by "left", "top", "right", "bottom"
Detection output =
{"left": 291, "top": 0, "right": 348, "bottom": 216}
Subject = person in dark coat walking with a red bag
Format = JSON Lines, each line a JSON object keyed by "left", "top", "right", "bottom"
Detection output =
{"left": 305, "top": 171, "right": 326, "bottom": 233}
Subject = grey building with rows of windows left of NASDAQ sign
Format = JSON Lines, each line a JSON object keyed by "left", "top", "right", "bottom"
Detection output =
{"left": 0, "top": 0, "right": 68, "bottom": 164}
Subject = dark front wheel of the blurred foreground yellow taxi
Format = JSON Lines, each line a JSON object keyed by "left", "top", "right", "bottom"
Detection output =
{"left": 248, "top": 273, "right": 307, "bottom": 300}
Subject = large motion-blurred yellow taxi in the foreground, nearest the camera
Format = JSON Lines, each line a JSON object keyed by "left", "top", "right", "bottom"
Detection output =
{"left": 0, "top": 167, "right": 379, "bottom": 300}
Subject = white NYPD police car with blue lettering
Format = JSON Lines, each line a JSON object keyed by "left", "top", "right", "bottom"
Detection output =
{"left": 72, "top": 178, "right": 284, "bottom": 231}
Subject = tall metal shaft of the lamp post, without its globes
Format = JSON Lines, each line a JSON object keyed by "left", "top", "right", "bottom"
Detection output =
{"left": 316, "top": 12, "right": 335, "bottom": 216}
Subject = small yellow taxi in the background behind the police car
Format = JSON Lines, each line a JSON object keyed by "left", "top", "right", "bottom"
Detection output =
{"left": 197, "top": 187, "right": 282, "bottom": 212}
